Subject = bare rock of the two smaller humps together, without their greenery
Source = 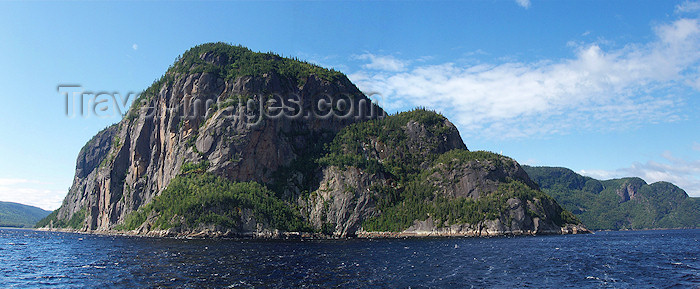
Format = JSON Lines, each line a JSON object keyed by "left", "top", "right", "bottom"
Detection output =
{"left": 301, "top": 111, "right": 588, "bottom": 237}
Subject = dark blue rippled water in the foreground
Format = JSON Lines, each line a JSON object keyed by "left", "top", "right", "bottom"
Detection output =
{"left": 0, "top": 229, "right": 700, "bottom": 288}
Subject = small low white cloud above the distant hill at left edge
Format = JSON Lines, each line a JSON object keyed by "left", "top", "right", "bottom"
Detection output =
{"left": 0, "top": 178, "right": 66, "bottom": 210}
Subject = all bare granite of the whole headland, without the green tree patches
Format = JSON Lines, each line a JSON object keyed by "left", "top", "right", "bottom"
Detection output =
{"left": 41, "top": 44, "right": 585, "bottom": 237}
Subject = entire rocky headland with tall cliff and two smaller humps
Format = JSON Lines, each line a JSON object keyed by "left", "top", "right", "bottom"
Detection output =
{"left": 40, "top": 43, "right": 585, "bottom": 237}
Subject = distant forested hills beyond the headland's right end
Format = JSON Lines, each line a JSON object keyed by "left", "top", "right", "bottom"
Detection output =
{"left": 523, "top": 166, "right": 700, "bottom": 230}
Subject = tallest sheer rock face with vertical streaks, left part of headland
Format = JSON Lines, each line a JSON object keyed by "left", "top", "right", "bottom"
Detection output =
{"left": 44, "top": 44, "right": 384, "bottom": 230}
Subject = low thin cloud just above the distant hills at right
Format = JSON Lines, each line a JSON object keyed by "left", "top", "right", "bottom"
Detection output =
{"left": 579, "top": 152, "right": 700, "bottom": 197}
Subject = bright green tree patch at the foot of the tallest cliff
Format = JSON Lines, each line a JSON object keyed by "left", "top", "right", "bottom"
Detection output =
{"left": 116, "top": 173, "right": 310, "bottom": 231}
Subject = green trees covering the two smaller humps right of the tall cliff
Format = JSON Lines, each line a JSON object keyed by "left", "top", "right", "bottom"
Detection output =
{"left": 318, "top": 108, "right": 580, "bottom": 232}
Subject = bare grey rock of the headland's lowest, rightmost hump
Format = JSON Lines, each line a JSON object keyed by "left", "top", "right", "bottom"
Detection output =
{"left": 388, "top": 154, "right": 588, "bottom": 236}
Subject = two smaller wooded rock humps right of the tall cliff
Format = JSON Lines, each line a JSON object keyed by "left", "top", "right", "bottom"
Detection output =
{"left": 307, "top": 109, "right": 587, "bottom": 237}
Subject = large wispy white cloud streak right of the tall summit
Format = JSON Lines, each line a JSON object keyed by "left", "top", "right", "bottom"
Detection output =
{"left": 350, "top": 18, "right": 700, "bottom": 139}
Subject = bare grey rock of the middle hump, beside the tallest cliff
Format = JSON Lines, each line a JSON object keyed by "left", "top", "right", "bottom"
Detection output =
{"left": 300, "top": 116, "right": 466, "bottom": 237}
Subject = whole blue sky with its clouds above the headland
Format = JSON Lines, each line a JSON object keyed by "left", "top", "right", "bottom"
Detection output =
{"left": 0, "top": 0, "right": 700, "bottom": 209}
